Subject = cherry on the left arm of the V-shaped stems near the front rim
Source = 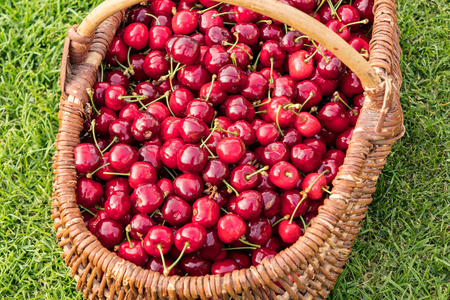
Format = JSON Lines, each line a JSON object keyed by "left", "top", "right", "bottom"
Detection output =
{"left": 144, "top": 226, "right": 174, "bottom": 257}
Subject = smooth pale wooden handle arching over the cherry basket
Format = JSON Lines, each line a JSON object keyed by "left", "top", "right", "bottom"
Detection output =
{"left": 78, "top": 0, "right": 381, "bottom": 88}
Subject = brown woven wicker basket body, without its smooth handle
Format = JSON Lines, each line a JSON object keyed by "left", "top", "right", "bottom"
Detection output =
{"left": 52, "top": 0, "right": 404, "bottom": 299}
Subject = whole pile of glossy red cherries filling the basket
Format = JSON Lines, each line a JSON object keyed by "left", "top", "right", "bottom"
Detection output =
{"left": 74, "top": 0, "right": 373, "bottom": 276}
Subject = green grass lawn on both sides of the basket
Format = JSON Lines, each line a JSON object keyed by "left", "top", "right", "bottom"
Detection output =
{"left": 0, "top": 0, "right": 450, "bottom": 300}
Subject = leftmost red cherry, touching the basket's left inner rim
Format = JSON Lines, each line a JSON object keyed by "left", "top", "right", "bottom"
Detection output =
{"left": 74, "top": 143, "right": 102, "bottom": 173}
